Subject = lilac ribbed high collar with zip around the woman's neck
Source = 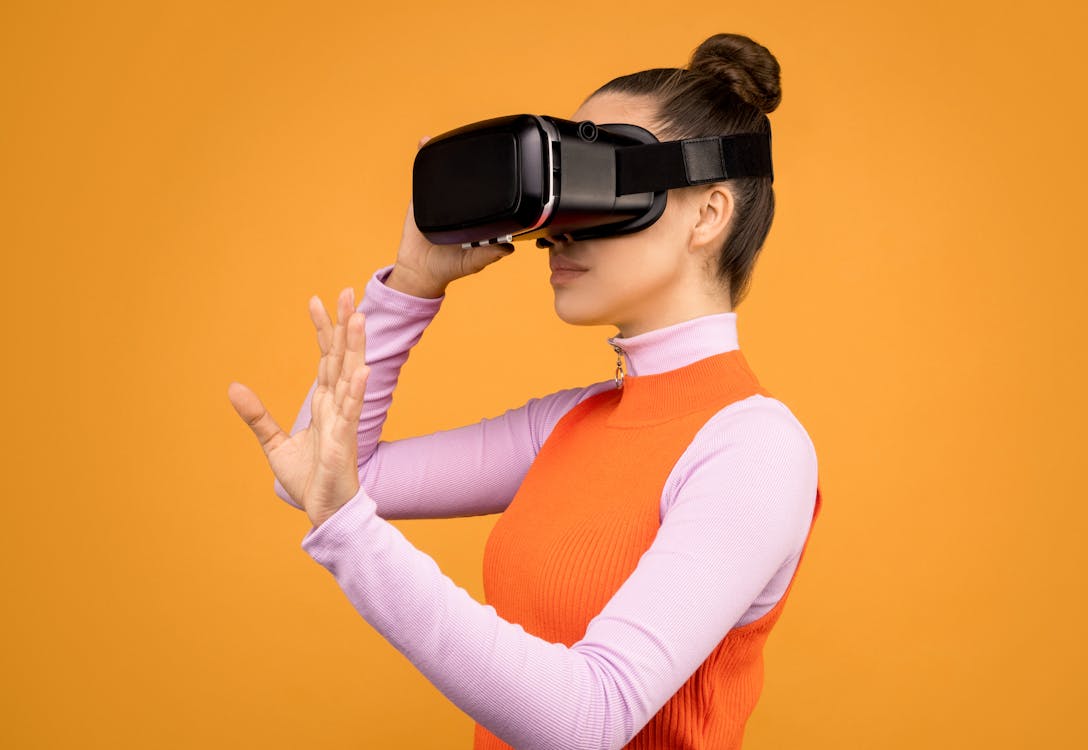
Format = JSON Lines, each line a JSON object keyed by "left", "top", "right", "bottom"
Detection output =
{"left": 607, "top": 311, "right": 740, "bottom": 378}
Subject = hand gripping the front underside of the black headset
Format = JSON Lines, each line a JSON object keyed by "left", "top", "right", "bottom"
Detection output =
{"left": 386, "top": 136, "right": 514, "bottom": 297}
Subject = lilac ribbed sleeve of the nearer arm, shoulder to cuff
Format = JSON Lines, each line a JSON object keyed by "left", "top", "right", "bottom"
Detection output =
{"left": 301, "top": 398, "right": 816, "bottom": 749}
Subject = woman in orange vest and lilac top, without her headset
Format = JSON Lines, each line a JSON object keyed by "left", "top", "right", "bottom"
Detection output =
{"left": 230, "top": 34, "right": 819, "bottom": 750}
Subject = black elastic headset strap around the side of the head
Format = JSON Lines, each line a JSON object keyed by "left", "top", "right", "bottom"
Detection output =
{"left": 616, "top": 133, "right": 775, "bottom": 196}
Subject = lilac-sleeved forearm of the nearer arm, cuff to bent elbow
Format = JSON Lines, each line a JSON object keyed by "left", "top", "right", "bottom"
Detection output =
{"left": 302, "top": 490, "right": 634, "bottom": 749}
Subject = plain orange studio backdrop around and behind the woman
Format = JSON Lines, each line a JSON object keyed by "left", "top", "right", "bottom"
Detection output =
{"left": 0, "top": 0, "right": 1088, "bottom": 749}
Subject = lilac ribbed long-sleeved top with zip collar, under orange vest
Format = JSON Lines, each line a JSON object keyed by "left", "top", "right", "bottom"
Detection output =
{"left": 274, "top": 265, "right": 817, "bottom": 749}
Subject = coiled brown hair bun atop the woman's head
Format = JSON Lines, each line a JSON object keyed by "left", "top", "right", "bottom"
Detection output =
{"left": 689, "top": 34, "right": 782, "bottom": 113}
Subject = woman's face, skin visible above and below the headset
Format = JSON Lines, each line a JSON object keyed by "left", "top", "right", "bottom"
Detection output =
{"left": 537, "top": 94, "right": 732, "bottom": 336}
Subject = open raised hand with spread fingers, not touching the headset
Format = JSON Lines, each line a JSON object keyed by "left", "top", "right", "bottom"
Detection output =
{"left": 227, "top": 290, "right": 370, "bottom": 526}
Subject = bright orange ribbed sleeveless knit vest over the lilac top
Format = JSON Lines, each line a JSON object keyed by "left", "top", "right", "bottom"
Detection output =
{"left": 473, "top": 349, "right": 820, "bottom": 750}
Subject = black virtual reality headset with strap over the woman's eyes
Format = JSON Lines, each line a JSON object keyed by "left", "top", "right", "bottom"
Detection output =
{"left": 412, "top": 114, "right": 775, "bottom": 248}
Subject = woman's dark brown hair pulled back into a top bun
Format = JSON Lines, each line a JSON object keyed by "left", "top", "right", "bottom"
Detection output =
{"left": 591, "top": 34, "right": 782, "bottom": 307}
